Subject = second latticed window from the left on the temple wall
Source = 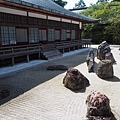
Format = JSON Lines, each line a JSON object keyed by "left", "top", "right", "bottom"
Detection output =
{"left": 29, "top": 28, "right": 39, "bottom": 43}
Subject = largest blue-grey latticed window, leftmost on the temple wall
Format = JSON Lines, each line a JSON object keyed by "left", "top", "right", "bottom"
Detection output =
{"left": 1, "top": 26, "right": 16, "bottom": 45}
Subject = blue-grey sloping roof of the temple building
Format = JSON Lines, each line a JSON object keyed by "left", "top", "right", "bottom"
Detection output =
{"left": 6, "top": 0, "right": 98, "bottom": 22}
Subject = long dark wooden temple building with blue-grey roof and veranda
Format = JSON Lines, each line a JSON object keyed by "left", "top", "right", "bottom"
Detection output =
{"left": 0, "top": 0, "right": 98, "bottom": 66}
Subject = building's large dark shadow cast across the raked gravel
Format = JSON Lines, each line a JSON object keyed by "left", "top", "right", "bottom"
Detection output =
{"left": 0, "top": 48, "right": 94, "bottom": 105}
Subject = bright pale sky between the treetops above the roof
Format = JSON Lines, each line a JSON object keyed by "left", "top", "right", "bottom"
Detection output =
{"left": 64, "top": 0, "right": 98, "bottom": 9}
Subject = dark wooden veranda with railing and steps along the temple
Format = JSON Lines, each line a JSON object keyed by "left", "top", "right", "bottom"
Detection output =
{"left": 0, "top": 39, "right": 91, "bottom": 66}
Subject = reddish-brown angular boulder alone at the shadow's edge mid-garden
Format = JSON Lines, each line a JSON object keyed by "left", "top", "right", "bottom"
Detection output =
{"left": 63, "top": 68, "right": 89, "bottom": 90}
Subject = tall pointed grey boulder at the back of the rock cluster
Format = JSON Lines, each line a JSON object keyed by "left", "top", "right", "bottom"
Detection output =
{"left": 97, "top": 41, "right": 111, "bottom": 60}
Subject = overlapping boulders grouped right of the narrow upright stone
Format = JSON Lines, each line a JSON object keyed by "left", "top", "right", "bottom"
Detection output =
{"left": 96, "top": 41, "right": 115, "bottom": 78}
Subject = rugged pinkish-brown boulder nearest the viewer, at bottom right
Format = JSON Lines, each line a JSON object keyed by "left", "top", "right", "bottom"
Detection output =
{"left": 86, "top": 92, "right": 115, "bottom": 120}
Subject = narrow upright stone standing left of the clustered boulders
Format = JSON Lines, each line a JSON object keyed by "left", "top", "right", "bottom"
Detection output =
{"left": 86, "top": 49, "right": 95, "bottom": 72}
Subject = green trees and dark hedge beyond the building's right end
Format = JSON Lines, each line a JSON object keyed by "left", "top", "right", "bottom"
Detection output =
{"left": 81, "top": 2, "right": 120, "bottom": 44}
